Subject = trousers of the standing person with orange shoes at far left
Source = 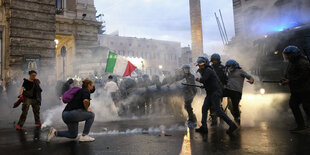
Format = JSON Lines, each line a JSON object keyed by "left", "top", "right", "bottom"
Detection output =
{"left": 18, "top": 98, "right": 41, "bottom": 126}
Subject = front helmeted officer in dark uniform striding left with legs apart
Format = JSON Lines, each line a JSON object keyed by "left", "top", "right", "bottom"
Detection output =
{"left": 196, "top": 57, "right": 238, "bottom": 134}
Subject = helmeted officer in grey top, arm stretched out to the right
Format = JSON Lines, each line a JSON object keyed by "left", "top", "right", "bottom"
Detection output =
{"left": 223, "top": 59, "right": 254, "bottom": 125}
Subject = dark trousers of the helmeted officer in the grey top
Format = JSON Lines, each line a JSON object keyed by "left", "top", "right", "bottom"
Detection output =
{"left": 223, "top": 89, "right": 242, "bottom": 119}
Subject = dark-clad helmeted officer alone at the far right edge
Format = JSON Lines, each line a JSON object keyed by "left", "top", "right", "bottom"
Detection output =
{"left": 282, "top": 46, "right": 310, "bottom": 132}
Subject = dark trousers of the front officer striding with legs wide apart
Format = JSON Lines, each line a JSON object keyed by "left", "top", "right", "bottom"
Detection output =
{"left": 201, "top": 91, "right": 235, "bottom": 127}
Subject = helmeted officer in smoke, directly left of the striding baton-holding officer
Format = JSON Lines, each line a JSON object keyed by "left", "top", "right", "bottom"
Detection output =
{"left": 178, "top": 64, "right": 197, "bottom": 127}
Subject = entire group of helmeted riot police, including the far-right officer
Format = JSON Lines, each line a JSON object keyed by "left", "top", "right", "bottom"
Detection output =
{"left": 100, "top": 46, "right": 310, "bottom": 133}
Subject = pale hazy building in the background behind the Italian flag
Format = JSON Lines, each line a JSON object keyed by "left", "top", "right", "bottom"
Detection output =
{"left": 99, "top": 35, "right": 181, "bottom": 75}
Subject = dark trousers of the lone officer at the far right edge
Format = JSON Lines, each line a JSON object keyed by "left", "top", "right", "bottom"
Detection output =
{"left": 289, "top": 93, "right": 310, "bottom": 127}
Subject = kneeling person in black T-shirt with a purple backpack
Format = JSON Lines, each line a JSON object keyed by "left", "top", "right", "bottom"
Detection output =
{"left": 47, "top": 79, "right": 95, "bottom": 142}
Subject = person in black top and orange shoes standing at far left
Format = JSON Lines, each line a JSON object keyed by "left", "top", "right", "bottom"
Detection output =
{"left": 16, "top": 70, "right": 42, "bottom": 130}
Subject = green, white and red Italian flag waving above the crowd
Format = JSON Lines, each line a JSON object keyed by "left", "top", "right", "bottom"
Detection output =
{"left": 105, "top": 52, "right": 137, "bottom": 76}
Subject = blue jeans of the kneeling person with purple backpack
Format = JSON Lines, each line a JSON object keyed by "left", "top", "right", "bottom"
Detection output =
{"left": 56, "top": 109, "right": 95, "bottom": 138}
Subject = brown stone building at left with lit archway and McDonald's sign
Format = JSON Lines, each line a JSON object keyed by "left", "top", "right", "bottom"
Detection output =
{"left": 0, "top": 0, "right": 102, "bottom": 81}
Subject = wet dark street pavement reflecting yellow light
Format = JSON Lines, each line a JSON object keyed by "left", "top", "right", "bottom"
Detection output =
{"left": 0, "top": 117, "right": 310, "bottom": 155}
